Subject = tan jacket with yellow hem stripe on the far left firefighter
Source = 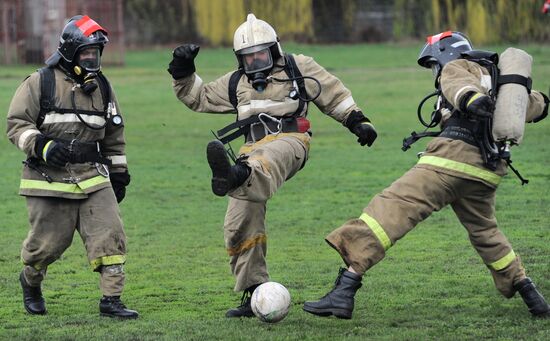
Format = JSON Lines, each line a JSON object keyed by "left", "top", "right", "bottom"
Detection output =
{"left": 7, "top": 68, "right": 127, "bottom": 199}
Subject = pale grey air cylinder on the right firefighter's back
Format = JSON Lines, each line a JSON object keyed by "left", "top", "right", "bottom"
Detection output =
{"left": 493, "top": 47, "right": 533, "bottom": 144}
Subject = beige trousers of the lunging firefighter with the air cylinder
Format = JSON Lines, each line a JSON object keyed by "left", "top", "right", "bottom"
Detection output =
{"left": 326, "top": 167, "right": 526, "bottom": 297}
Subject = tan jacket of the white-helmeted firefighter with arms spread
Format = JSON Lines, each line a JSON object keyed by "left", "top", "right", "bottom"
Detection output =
{"left": 173, "top": 55, "right": 360, "bottom": 124}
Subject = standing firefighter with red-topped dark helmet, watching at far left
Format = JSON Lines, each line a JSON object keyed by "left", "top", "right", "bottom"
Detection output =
{"left": 7, "top": 15, "right": 138, "bottom": 318}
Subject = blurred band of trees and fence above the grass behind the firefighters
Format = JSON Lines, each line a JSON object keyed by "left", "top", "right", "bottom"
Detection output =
{"left": 5, "top": 0, "right": 550, "bottom": 64}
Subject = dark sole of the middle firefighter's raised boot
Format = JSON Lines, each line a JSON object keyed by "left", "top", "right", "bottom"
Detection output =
{"left": 206, "top": 140, "right": 231, "bottom": 197}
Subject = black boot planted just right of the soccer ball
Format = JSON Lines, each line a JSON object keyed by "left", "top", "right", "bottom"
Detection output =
{"left": 304, "top": 268, "right": 362, "bottom": 319}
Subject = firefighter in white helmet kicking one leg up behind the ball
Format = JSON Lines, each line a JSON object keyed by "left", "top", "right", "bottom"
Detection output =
{"left": 168, "top": 14, "right": 376, "bottom": 317}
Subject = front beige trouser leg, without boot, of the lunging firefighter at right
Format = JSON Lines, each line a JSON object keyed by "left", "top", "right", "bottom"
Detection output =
{"left": 326, "top": 167, "right": 463, "bottom": 274}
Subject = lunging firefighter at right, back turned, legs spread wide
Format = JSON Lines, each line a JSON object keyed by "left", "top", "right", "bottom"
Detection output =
{"left": 303, "top": 31, "right": 550, "bottom": 319}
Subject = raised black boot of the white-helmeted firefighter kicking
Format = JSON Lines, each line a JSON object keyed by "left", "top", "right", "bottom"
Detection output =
{"left": 206, "top": 140, "right": 250, "bottom": 197}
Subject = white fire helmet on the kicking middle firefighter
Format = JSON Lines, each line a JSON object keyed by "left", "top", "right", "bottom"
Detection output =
{"left": 233, "top": 13, "right": 283, "bottom": 74}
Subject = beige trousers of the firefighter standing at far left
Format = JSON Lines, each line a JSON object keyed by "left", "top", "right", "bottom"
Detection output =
{"left": 21, "top": 187, "right": 126, "bottom": 296}
